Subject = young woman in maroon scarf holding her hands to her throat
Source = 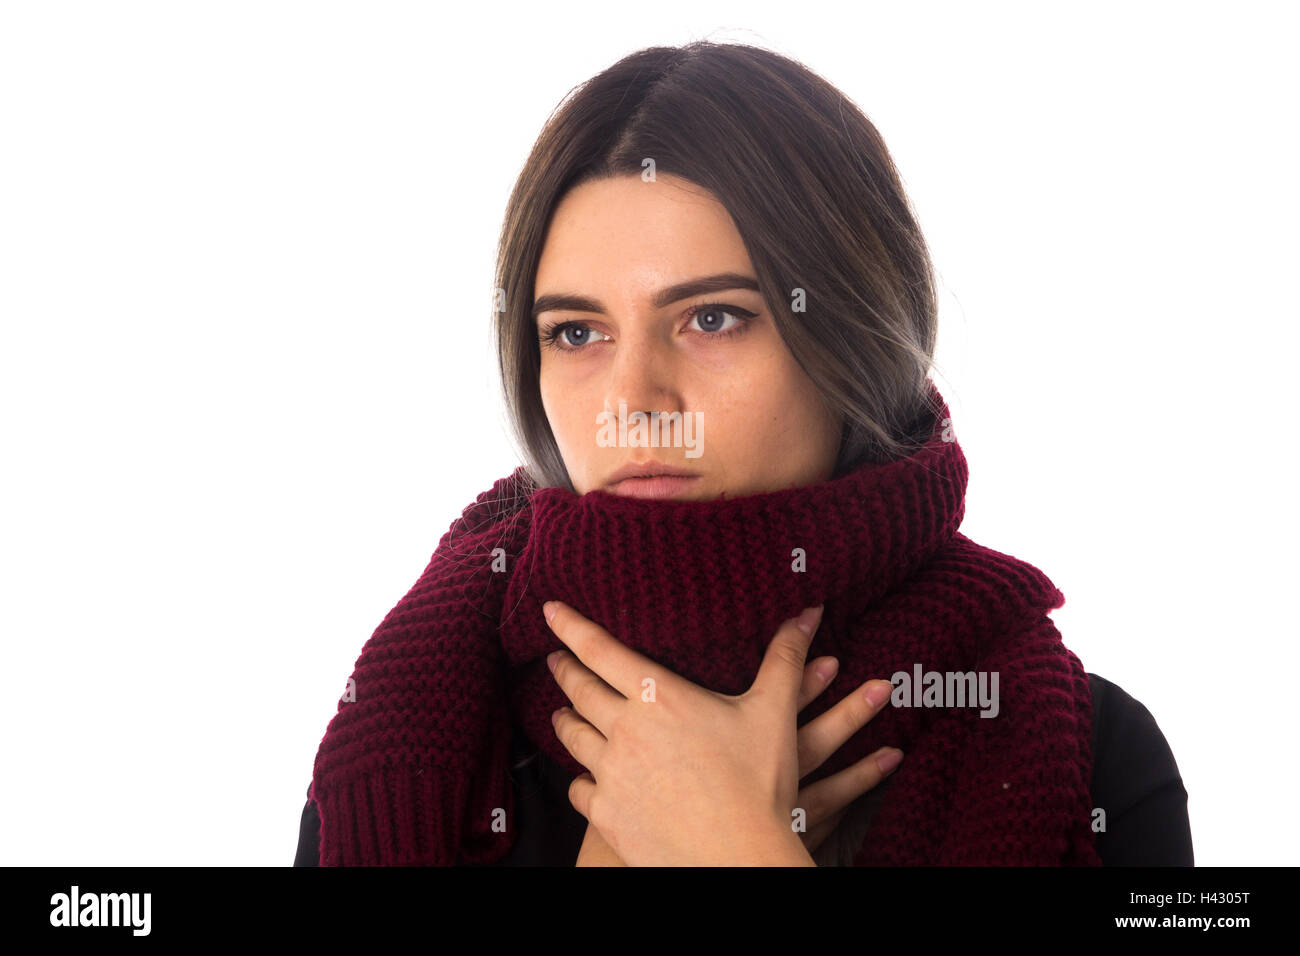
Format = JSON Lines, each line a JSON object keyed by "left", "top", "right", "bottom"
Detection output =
{"left": 295, "top": 42, "right": 1192, "bottom": 865}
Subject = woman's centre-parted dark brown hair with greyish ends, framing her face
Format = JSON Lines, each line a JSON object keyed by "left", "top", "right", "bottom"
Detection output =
{"left": 494, "top": 40, "right": 937, "bottom": 490}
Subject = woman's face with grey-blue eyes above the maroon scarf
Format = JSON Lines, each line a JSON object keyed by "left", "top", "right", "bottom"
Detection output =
{"left": 534, "top": 174, "right": 840, "bottom": 501}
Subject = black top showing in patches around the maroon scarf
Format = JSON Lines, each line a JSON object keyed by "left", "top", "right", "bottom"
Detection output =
{"left": 294, "top": 674, "right": 1192, "bottom": 866}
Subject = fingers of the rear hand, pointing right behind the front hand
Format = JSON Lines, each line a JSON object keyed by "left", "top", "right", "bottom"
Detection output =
{"left": 796, "top": 657, "right": 902, "bottom": 853}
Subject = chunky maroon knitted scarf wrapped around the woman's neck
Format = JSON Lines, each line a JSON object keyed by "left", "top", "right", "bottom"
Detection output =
{"left": 312, "top": 386, "right": 1100, "bottom": 865}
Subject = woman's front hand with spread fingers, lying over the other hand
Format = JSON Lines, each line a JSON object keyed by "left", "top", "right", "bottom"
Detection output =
{"left": 546, "top": 601, "right": 820, "bottom": 866}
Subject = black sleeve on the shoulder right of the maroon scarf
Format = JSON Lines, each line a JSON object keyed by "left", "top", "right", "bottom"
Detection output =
{"left": 1088, "top": 674, "right": 1193, "bottom": 866}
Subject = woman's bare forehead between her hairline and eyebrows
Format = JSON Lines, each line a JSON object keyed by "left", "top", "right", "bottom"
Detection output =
{"left": 536, "top": 174, "right": 753, "bottom": 298}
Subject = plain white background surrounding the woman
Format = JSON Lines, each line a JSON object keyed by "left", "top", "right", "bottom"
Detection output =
{"left": 0, "top": 0, "right": 1300, "bottom": 865}
